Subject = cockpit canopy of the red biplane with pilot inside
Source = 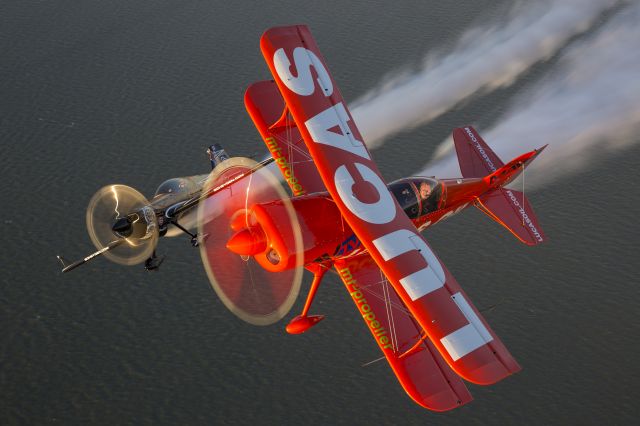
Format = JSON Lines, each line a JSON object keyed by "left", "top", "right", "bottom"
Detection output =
{"left": 389, "top": 177, "right": 446, "bottom": 219}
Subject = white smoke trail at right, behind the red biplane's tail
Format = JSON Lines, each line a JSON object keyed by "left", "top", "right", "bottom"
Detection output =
{"left": 422, "top": 3, "right": 640, "bottom": 186}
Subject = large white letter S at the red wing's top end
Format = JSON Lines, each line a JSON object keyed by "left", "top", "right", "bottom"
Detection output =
{"left": 273, "top": 47, "right": 333, "bottom": 96}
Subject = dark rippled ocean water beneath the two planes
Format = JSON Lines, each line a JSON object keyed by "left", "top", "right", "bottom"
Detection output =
{"left": 0, "top": 0, "right": 640, "bottom": 425}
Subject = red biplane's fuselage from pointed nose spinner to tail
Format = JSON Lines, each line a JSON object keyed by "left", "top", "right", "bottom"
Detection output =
{"left": 227, "top": 146, "right": 538, "bottom": 272}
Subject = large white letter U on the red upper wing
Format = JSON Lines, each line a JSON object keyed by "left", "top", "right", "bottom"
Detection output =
{"left": 373, "top": 229, "right": 445, "bottom": 301}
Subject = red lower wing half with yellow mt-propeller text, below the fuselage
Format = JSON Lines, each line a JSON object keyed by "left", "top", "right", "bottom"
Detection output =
{"left": 335, "top": 254, "right": 473, "bottom": 411}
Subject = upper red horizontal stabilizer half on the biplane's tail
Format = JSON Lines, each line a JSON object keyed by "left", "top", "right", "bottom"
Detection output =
{"left": 453, "top": 126, "right": 504, "bottom": 178}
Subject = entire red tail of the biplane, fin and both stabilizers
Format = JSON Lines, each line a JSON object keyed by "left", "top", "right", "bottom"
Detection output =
{"left": 453, "top": 126, "right": 546, "bottom": 245}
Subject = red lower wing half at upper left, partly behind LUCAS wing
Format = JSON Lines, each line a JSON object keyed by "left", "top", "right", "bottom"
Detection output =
{"left": 244, "top": 80, "right": 326, "bottom": 196}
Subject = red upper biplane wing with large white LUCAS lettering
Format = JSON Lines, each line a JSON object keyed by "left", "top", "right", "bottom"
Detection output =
{"left": 260, "top": 26, "right": 520, "bottom": 384}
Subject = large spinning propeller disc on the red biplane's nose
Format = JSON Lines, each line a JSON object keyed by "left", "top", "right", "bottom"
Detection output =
{"left": 198, "top": 158, "right": 302, "bottom": 325}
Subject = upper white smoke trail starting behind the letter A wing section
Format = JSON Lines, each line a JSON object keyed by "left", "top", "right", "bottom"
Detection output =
{"left": 351, "top": 0, "right": 618, "bottom": 148}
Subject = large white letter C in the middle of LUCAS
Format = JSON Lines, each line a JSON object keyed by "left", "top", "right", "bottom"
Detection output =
{"left": 333, "top": 163, "right": 396, "bottom": 225}
